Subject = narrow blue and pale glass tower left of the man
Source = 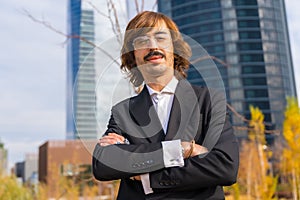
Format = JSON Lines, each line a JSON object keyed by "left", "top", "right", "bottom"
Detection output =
{"left": 67, "top": 0, "right": 98, "bottom": 139}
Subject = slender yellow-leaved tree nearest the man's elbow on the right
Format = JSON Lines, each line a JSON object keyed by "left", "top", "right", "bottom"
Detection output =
{"left": 238, "top": 106, "right": 277, "bottom": 200}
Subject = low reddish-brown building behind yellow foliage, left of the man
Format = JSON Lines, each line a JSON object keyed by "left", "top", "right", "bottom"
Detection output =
{"left": 38, "top": 140, "right": 112, "bottom": 198}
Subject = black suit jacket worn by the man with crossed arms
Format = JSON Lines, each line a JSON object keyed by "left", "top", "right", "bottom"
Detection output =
{"left": 93, "top": 80, "right": 239, "bottom": 200}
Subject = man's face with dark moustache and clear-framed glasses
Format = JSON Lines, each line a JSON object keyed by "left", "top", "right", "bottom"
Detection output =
{"left": 133, "top": 21, "right": 174, "bottom": 81}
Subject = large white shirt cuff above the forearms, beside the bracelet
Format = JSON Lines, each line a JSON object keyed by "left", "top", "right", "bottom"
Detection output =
{"left": 161, "top": 140, "right": 184, "bottom": 167}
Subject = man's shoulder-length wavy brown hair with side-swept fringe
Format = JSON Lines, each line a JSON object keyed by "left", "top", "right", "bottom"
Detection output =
{"left": 121, "top": 11, "right": 192, "bottom": 87}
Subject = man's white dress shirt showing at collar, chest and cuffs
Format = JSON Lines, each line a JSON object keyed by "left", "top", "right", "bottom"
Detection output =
{"left": 141, "top": 77, "right": 184, "bottom": 194}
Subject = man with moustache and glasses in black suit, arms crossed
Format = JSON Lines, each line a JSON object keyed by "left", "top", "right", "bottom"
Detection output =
{"left": 93, "top": 11, "right": 239, "bottom": 200}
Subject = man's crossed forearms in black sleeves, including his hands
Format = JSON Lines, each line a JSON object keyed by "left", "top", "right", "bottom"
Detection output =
{"left": 93, "top": 115, "right": 239, "bottom": 192}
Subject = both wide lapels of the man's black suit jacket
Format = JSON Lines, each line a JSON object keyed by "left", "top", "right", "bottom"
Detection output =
{"left": 129, "top": 80, "right": 201, "bottom": 143}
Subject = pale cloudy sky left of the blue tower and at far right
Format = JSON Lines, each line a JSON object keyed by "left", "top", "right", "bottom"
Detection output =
{"left": 0, "top": 0, "right": 300, "bottom": 170}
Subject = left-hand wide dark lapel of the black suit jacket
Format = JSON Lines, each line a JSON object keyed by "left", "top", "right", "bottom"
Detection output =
{"left": 129, "top": 87, "right": 165, "bottom": 143}
